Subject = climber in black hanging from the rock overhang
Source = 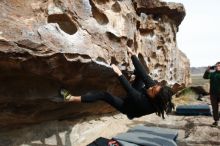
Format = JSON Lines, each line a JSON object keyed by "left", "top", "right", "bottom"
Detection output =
{"left": 60, "top": 47, "right": 174, "bottom": 119}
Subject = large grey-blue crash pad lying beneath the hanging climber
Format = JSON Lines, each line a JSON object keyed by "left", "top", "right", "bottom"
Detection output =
{"left": 113, "top": 125, "right": 178, "bottom": 146}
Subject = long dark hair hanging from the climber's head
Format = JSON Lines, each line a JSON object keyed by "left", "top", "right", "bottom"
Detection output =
{"left": 152, "top": 86, "right": 174, "bottom": 119}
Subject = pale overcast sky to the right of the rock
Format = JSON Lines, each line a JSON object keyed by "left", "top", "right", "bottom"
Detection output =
{"left": 163, "top": 0, "right": 220, "bottom": 67}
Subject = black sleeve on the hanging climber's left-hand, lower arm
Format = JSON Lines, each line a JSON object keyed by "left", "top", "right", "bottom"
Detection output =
{"left": 118, "top": 75, "right": 141, "bottom": 97}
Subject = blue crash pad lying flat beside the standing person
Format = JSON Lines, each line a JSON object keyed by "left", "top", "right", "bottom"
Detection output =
{"left": 176, "top": 104, "right": 211, "bottom": 116}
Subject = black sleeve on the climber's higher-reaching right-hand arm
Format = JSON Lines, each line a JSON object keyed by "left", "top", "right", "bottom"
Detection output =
{"left": 131, "top": 55, "right": 156, "bottom": 88}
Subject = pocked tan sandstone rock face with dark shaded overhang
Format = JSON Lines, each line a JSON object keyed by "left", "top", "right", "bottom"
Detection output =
{"left": 0, "top": 0, "right": 189, "bottom": 127}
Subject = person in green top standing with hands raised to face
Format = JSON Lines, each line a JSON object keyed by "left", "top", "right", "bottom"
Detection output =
{"left": 203, "top": 62, "right": 220, "bottom": 127}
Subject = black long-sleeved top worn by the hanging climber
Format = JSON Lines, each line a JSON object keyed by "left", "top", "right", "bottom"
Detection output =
{"left": 119, "top": 55, "right": 156, "bottom": 119}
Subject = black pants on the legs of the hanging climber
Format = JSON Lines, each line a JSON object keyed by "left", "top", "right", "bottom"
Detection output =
{"left": 81, "top": 76, "right": 144, "bottom": 114}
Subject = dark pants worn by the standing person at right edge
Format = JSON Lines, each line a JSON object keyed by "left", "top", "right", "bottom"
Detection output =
{"left": 210, "top": 95, "right": 220, "bottom": 121}
